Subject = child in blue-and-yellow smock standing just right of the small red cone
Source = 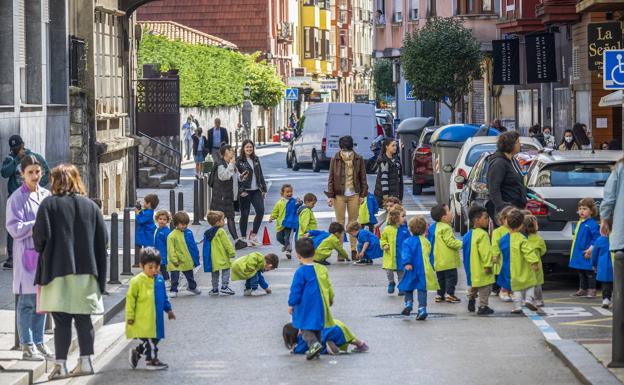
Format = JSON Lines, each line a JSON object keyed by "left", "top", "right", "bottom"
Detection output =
{"left": 269, "top": 184, "right": 301, "bottom": 259}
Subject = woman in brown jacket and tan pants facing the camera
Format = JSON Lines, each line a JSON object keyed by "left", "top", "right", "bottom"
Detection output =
{"left": 325, "top": 136, "right": 368, "bottom": 258}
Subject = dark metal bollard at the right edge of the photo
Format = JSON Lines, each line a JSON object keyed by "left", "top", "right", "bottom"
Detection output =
{"left": 607, "top": 250, "right": 624, "bottom": 368}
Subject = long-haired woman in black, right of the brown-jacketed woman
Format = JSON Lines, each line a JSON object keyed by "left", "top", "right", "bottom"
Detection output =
{"left": 375, "top": 138, "right": 403, "bottom": 206}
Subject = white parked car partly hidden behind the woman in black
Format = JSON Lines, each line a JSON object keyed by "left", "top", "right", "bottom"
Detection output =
{"left": 449, "top": 136, "right": 543, "bottom": 231}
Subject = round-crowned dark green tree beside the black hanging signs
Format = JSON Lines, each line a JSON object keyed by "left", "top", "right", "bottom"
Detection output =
{"left": 401, "top": 18, "right": 483, "bottom": 122}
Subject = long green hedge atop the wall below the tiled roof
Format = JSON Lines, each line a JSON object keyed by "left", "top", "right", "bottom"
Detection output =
{"left": 138, "top": 31, "right": 285, "bottom": 108}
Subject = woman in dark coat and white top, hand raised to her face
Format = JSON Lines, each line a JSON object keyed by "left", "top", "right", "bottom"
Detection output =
{"left": 210, "top": 144, "right": 247, "bottom": 250}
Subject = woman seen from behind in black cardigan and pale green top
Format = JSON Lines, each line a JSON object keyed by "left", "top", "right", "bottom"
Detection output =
{"left": 33, "top": 164, "right": 108, "bottom": 380}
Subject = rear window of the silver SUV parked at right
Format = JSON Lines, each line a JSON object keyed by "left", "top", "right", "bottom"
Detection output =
{"left": 535, "top": 163, "right": 611, "bottom": 187}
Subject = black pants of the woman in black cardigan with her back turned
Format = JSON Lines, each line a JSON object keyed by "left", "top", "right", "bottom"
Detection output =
{"left": 52, "top": 312, "right": 95, "bottom": 360}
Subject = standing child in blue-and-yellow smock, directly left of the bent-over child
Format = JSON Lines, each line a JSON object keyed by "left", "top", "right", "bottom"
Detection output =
{"left": 202, "top": 211, "right": 236, "bottom": 296}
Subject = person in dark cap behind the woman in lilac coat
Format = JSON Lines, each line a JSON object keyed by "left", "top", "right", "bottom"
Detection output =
{"left": 0, "top": 135, "right": 50, "bottom": 269}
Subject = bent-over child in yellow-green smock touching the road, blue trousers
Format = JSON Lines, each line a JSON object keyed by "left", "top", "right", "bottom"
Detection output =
{"left": 232, "top": 252, "right": 279, "bottom": 297}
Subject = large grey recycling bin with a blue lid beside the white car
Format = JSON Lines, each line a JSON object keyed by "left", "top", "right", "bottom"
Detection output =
{"left": 431, "top": 124, "right": 498, "bottom": 204}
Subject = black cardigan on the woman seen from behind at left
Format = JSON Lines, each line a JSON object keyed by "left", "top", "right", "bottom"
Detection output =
{"left": 33, "top": 194, "right": 108, "bottom": 292}
